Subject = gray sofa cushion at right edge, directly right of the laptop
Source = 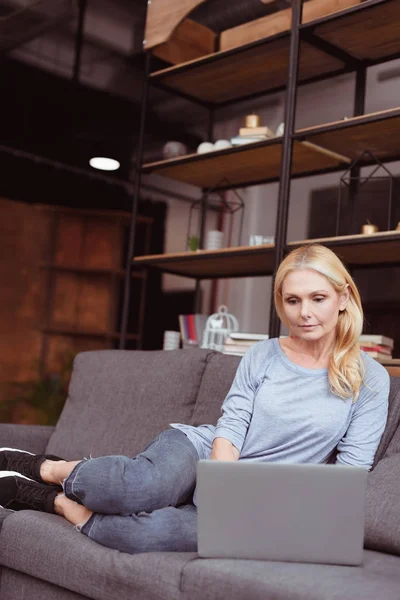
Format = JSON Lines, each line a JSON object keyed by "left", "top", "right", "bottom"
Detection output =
{"left": 365, "top": 453, "right": 400, "bottom": 556}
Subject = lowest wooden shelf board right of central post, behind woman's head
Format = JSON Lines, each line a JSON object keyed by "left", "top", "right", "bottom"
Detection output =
{"left": 287, "top": 231, "right": 400, "bottom": 265}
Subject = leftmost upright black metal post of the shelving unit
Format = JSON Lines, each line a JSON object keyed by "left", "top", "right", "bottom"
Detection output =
{"left": 119, "top": 52, "right": 151, "bottom": 350}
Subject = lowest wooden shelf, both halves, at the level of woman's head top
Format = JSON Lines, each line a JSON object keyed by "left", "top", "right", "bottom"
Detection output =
{"left": 134, "top": 231, "right": 400, "bottom": 279}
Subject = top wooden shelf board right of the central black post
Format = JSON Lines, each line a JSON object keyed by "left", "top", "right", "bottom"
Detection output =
{"left": 310, "top": 0, "right": 400, "bottom": 62}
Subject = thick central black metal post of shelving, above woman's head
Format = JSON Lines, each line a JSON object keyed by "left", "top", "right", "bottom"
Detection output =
{"left": 269, "top": 2, "right": 303, "bottom": 337}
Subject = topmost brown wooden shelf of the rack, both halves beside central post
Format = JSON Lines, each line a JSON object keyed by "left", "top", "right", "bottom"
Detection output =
{"left": 150, "top": 0, "right": 400, "bottom": 105}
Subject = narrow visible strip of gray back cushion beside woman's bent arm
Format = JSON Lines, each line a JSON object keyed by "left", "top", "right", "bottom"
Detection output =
{"left": 190, "top": 352, "right": 240, "bottom": 425}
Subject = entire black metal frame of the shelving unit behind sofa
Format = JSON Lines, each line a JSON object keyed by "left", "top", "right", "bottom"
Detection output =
{"left": 120, "top": 0, "right": 400, "bottom": 348}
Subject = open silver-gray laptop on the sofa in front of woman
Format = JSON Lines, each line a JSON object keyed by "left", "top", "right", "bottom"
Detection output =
{"left": 196, "top": 460, "right": 368, "bottom": 565}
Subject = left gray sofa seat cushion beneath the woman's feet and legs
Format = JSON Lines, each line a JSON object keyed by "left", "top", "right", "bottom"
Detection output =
{"left": 0, "top": 510, "right": 197, "bottom": 600}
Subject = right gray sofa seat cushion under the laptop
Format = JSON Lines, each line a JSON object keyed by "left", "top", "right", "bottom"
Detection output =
{"left": 181, "top": 551, "right": 400, "bottom": 600}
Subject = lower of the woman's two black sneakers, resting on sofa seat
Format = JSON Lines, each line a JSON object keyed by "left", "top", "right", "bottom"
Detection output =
{"left": 0, "top": 472, "right": 59, "bottom": 513}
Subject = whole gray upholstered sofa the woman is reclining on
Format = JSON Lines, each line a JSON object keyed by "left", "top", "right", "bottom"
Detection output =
{"left": 0, "top": 349, "right": 400, "bottom": 600}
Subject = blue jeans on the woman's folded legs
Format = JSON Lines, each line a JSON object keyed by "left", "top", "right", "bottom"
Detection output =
{"left": 64, "top": 429, "right": 199, "bottom": 554}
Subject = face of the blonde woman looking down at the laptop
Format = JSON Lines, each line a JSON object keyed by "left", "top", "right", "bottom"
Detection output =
{"left": 282, "top": 269, "right": 349, "bottom": 341}
